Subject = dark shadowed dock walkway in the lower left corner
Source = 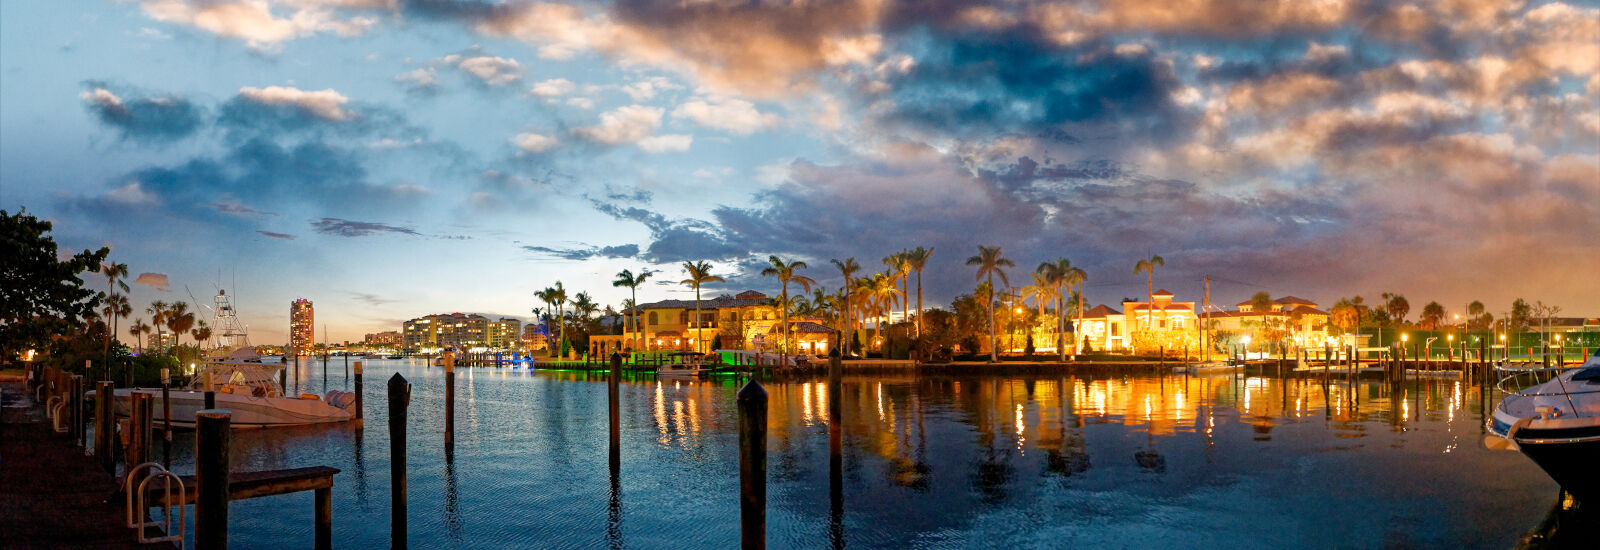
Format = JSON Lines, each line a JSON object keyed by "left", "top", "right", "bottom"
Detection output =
{"left": 0, "top": 377, "right": 174, "bottom": 548}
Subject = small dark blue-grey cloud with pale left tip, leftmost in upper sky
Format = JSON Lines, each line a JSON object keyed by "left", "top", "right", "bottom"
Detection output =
{"left": 78, "top": 82, "right": 203, "bottom": 142}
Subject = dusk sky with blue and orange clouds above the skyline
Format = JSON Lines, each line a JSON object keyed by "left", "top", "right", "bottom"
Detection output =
{"left": 0, "top": 0, "right": 1600, "bottom": 344}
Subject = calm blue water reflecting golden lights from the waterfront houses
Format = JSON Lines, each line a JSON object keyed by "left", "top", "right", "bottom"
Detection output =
{"left": 152, "top": 360, "right": 1557, "bottom": 550}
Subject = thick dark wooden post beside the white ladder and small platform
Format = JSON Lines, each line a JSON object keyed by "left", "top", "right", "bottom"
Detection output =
{"left": 195, "top": 409, "right": 232, "bottom": 548}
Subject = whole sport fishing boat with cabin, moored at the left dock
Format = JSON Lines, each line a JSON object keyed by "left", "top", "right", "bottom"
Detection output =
{"left": 101, "top": 349, "right": 355, "bottom": 428}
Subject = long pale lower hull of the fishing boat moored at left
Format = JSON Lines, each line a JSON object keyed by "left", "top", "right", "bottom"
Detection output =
{"left": 112, "top": 390, "right": 350, "bottom": 428}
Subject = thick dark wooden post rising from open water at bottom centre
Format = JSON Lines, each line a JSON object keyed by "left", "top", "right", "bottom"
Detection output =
{"left": 738, "top": 381, "right": 766, "bottom": 550}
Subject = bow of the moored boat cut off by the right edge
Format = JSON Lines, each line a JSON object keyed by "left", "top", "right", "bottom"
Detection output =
{"left": 1485, "top": 350, "right": 1600, "bottom": 502}
